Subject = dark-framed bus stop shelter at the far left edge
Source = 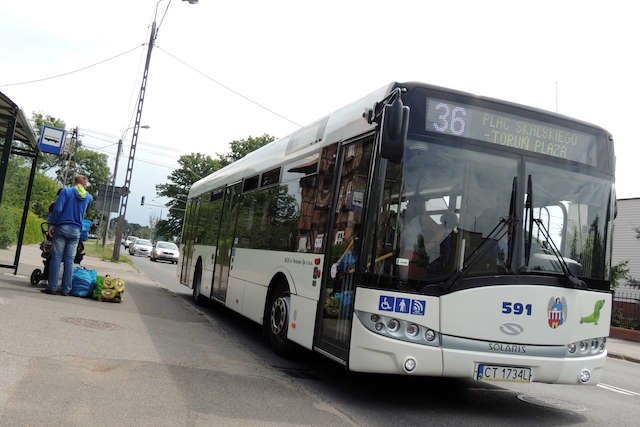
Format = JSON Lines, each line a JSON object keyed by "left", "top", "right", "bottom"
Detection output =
{"left": 0, "top": 92, "right": 39, "bottom": 274}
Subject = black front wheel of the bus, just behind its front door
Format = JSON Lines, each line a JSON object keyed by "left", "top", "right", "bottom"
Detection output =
{"left": 265, "top": 283, "right": 293, "bottom": 357}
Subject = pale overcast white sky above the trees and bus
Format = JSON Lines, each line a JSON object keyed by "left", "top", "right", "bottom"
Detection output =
{"left": 0, "top": 0, "right": 640, "bottom": 225}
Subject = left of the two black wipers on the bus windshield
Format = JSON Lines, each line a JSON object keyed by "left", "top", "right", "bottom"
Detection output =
{"left": 445, "top": 177, "right": 518, "bottom": 288}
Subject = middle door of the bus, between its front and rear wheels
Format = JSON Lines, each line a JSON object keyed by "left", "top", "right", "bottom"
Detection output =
{"left": 212, "top": 184, "right": 242, "bottom": 302}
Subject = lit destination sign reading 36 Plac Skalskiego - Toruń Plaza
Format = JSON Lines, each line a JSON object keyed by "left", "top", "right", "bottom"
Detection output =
{"left": 425, "top": 98, "right": 598, "bottom": 166}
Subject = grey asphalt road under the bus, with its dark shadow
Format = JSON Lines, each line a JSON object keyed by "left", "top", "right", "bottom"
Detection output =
{"left": 134, "top": 258, "right": 640, "bottom": 426}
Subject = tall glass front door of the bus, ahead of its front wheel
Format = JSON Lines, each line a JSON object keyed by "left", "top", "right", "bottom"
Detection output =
{"left": 315, "top": 137, "right": 373, "bottom": 362}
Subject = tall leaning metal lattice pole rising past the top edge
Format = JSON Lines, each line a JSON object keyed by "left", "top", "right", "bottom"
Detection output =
{"left": 111, "top": 0, "right": 197, "bottom": 261}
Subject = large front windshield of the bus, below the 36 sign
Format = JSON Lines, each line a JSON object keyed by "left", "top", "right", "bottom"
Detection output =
{"left": 374, "top": 139, "right": 611, "bottom": 289}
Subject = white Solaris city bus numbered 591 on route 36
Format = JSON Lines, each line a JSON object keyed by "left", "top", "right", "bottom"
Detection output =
{"left": 178, "top": 83, "right": 615, "bottom": 384}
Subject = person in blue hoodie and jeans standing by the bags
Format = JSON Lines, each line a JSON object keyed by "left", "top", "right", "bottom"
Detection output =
{"left": 42, "top": 175, "right": 93, "bottom": 296}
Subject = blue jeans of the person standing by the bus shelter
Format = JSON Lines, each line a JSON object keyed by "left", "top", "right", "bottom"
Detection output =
{"left": 47, "top": 224, "right": 80, "bottom": 294}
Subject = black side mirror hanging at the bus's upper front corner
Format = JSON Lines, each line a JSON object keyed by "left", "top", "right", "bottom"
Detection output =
{"left": 380, "top": 97, "right": 409, "bottom": 163}
